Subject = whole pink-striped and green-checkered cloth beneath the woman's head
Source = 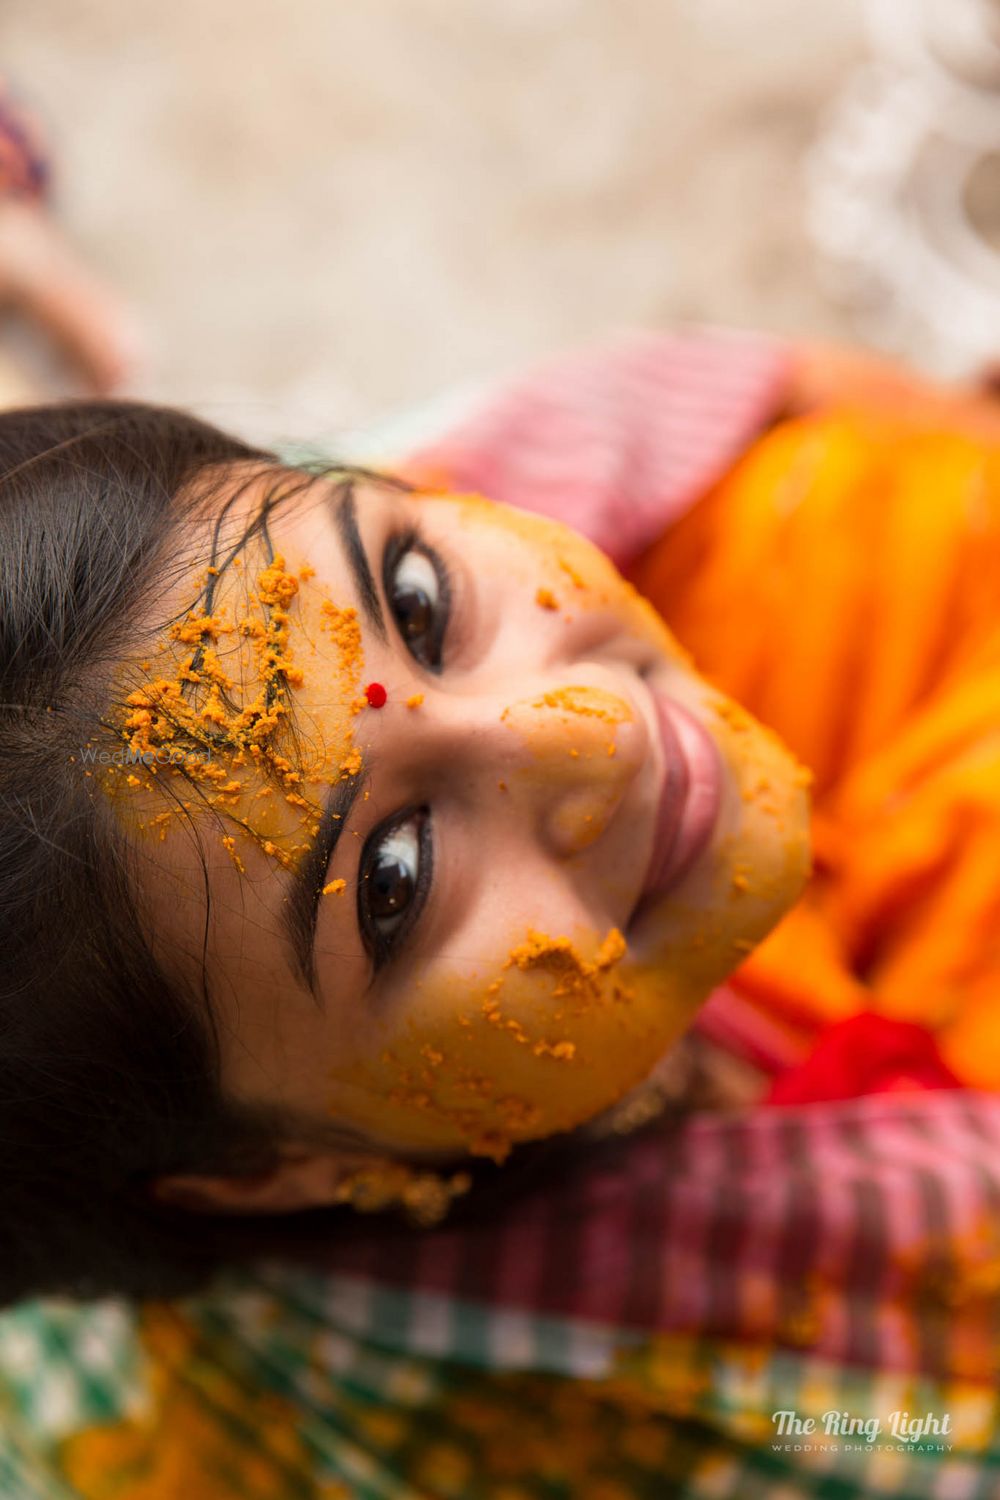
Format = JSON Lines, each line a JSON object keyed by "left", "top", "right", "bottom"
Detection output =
{"left": 0, "top": 1092, "right": 1000, "bottom": 1500}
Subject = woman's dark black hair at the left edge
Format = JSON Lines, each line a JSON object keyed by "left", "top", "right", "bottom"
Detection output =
{"left": 0, "top": 402, "right": 344, "bottom": 1302}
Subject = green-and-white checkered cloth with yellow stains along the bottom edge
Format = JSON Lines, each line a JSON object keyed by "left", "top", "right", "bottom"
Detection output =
{"left": 0, "top": 1266, "right": 1000, "bottom": 1500}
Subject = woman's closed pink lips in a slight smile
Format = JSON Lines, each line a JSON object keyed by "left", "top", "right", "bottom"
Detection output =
{"left": 640, "top": 689, "right": 723, "bottom": 905}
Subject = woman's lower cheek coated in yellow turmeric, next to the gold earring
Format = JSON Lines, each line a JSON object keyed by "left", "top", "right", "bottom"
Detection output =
{"left": 330, "top": 929, "right": 719, "bottom": 1161}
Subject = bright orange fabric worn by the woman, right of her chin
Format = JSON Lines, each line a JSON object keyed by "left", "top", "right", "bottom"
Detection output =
{"left": 631, "top": 383, "right": 1000, "bottom": 1088}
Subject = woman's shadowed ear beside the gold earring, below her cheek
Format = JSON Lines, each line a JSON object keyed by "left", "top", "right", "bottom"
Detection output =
{"left": 150, "top": 1146, "right": 379, "bottom": 1214}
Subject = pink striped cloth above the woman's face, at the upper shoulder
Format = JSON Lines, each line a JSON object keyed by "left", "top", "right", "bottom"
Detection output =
{"left": 403, "top": 329, "right": 792, "bottom": 566}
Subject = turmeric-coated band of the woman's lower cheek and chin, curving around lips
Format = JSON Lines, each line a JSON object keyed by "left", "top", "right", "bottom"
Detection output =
{"left": 328, "top": 699, "right": 808, "bottom": 1161}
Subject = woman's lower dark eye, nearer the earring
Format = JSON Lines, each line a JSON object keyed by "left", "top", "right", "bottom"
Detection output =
{"left": 358, "top": 810, "right": 430, "bottom": 966}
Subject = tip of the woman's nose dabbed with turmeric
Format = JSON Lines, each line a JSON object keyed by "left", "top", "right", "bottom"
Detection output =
{"left": 498, "top": 684, "right": 649, "bottom": 858}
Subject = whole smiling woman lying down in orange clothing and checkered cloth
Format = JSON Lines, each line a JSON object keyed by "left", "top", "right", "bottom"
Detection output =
{"left": 0, "top": 335, "right": 1000, "bottom": 1500}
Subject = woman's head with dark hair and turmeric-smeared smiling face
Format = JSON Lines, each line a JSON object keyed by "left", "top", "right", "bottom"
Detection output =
{"left": 0, "top": 351, "right": 808, "bottom": 1290}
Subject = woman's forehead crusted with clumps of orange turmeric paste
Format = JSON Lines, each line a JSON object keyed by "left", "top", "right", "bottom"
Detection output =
{"left": 105, "top": 474, "right": 377, "bottom": 872}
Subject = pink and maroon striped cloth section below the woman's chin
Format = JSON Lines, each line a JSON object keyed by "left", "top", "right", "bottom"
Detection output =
{"left": 316, "top": 1092, "right": 1000, "bottom": 1382}
